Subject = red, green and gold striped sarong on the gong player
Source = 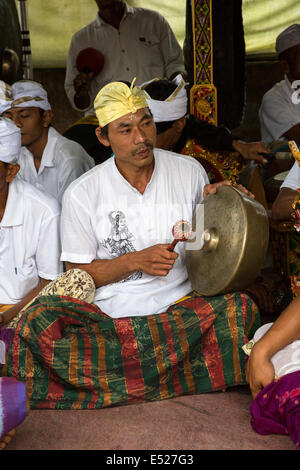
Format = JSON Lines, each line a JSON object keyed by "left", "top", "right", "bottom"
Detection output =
{"left": 4, "top": 293, "right": 260, "bottom": 409}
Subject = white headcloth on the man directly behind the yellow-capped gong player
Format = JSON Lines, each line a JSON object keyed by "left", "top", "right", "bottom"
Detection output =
{"left": 141, "top": 74, "right": 188, "bottom": 122}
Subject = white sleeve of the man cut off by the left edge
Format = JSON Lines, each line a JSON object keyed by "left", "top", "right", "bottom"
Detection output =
{"left": 36, "top": 213, "right": 63, "bottom": 280}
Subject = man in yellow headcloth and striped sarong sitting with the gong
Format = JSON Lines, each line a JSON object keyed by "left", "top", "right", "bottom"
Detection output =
{"left": 2, "top": 82, "right": 259, "bottom": 409}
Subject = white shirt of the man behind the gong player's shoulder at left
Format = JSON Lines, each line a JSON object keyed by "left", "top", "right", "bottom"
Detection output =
{"left": 19, "top": 127, "right": 95, "bottom": 202}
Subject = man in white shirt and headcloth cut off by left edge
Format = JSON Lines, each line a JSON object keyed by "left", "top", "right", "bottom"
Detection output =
{"left": 0, "top": 118, "right": 63, "bottom": 326}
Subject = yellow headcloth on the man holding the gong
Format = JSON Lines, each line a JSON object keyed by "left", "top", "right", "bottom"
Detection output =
{"left": 94, "top": 79, "right": 148, "bottom": 127}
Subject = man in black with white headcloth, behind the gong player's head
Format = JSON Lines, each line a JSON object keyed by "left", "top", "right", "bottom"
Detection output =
{"left": 142, "top": 75, "right": 268, "bottom": 163}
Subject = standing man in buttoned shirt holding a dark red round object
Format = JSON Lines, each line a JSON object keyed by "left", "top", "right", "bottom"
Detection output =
{"left": 65, "top": 0, "right": 185, "bottom": 115}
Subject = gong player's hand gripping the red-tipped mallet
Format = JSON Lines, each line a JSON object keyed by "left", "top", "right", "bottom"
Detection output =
{"left": 134, "top": 244, "right": 178, "bottom": 276}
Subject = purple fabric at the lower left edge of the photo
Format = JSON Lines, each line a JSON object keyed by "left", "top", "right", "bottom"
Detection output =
{"left": 0, "top": 377, "right": 26, "bottom": 438}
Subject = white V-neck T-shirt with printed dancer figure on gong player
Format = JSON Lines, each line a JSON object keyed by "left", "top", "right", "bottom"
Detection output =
{"left": 61, "top": 149, "right": 209, "bottom": 317}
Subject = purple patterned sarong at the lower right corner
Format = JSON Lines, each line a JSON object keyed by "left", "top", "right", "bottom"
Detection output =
{"left": 250, "top": 371, "right": 300, "bottom": 450}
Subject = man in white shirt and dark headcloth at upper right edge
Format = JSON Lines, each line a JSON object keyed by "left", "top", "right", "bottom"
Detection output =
{"left": 259, "top": 24, "right": 300, "bottom": 145}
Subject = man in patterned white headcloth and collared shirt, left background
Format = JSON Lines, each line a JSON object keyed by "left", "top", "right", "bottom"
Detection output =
{"left": 0, "top": 80, "right": 94, "bottom": 202}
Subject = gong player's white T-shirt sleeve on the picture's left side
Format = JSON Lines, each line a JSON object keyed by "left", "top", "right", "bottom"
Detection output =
{"left": 61, "top": 187, "right": 97, "bottom": 263}
